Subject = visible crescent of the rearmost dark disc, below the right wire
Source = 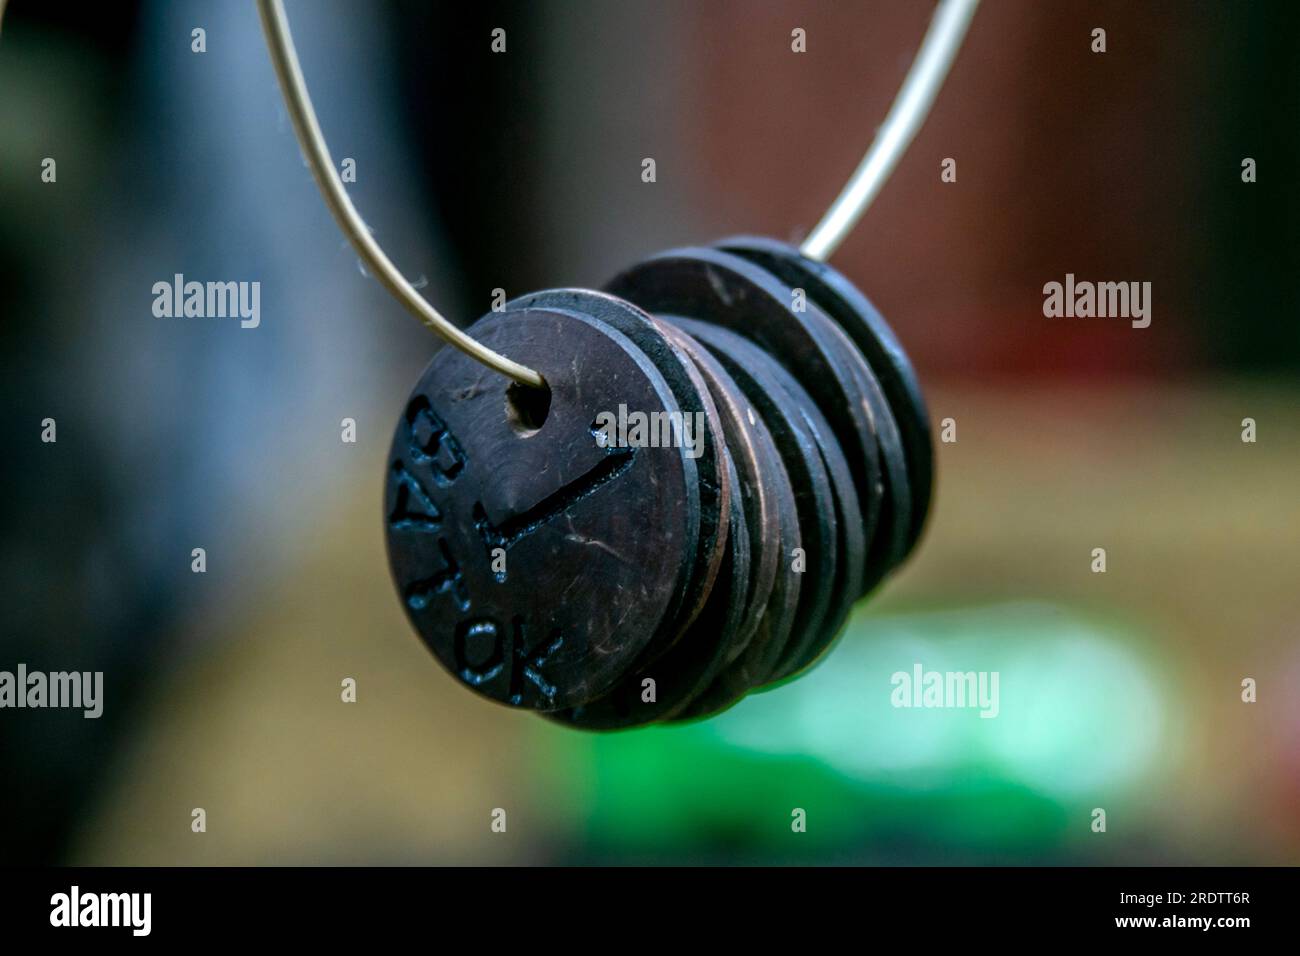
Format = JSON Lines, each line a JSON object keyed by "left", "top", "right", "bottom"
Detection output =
{"left": 715, "top": 235, "right": 935, "bottom": 550}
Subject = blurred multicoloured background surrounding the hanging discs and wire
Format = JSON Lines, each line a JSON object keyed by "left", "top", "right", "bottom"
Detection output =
{"left": 0, "top": 0, "right": 1300, "bottom": 864}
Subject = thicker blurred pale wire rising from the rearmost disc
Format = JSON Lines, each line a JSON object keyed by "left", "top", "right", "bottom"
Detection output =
{"left": 800, "top": 0, "right": 979, "bottom": 261}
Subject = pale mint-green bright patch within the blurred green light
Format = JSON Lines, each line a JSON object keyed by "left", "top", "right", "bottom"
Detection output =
{"left": 714, "top": 605, "right": 1162, "bottom": 796}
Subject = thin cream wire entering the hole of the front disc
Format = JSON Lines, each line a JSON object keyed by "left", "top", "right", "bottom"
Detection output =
{"left": 257, "top": 0, "right": 546, "bottom": 388}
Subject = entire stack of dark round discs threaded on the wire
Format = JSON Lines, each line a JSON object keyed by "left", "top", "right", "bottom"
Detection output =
{"left": 385, "top": 237, "right": 933, "bottom": 730}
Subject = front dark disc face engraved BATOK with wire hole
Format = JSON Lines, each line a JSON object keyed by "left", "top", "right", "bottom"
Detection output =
{"left": 384, "top": 310, "right": 699, "bottom": 710}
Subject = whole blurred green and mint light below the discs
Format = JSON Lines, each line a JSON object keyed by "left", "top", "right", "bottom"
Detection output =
{"left": 546, "top": 604, "right": 1166, "bottom": 856}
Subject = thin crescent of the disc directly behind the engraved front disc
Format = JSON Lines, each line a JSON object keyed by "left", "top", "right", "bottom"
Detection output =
{"left": 506, "top": 289, "right": 732, "bottom": 659}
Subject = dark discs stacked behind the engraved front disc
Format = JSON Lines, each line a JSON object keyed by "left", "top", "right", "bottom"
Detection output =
{"left": 551, "top": 237, "right": 933, "bottom": 730}
